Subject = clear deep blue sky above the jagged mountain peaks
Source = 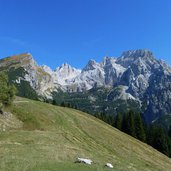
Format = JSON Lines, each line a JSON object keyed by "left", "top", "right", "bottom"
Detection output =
{"left": 0, "top": 0, "right": 171, "bottom": 69}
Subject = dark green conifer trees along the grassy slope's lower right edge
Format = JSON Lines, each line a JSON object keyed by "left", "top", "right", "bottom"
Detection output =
{"left": 95, "top": 110, "right": 171, "bottom": 157}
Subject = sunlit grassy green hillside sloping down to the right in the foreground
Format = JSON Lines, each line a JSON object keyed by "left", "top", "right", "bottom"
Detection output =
{"left": 0, "top": 98, "right": 171, "bottom": 171}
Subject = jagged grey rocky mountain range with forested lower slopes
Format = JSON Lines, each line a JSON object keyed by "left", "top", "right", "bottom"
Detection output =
{"left": 0, "top": 50, "right": 171, "bottom": 123}
